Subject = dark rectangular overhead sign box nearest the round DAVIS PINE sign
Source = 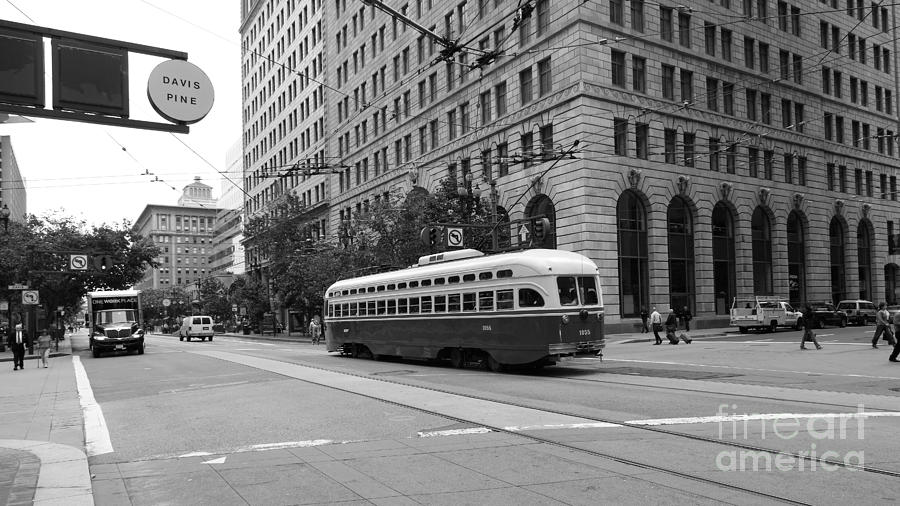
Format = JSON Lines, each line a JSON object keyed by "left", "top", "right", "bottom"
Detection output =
{"left": 52, "top": 39, "right": 128, "bottom": 118}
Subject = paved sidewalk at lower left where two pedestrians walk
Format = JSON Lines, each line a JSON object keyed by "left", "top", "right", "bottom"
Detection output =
{"left": 0, "top": 335, "right": 94, "bottom": 506}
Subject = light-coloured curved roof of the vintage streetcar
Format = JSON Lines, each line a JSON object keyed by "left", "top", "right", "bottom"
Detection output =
{"left": 325, "top": 249, "right": 598, "bottom": 298}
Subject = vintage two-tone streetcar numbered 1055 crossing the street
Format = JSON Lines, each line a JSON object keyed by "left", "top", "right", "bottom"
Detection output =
{"left": 324, "top": 249, "right": 605, "bottom": 371}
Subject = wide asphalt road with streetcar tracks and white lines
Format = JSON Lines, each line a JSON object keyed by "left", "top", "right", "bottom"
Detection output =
{"left": 73, "top": 326, "right": 900, "bottom": 505}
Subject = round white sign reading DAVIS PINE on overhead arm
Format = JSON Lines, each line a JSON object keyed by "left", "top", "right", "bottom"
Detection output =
{"left": 147, "top": 60, "right": 215, "bottom": 125}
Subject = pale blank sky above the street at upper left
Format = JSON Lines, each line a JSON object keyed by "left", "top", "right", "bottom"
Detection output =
{"left": 0, "top": 0, "right": 241, "bottom": 226}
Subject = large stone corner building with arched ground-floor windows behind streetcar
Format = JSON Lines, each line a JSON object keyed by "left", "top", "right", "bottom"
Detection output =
{"left": 239, "top": 0, "right": 900, "bottom": 331}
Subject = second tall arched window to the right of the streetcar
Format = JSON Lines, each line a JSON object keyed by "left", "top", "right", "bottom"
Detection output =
{"left": 667, "top": 197, "right": 696, "bottom": 313}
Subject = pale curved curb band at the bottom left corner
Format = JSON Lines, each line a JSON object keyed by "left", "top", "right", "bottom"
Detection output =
{"left": 0, "top": 439, "right": 94, "bottom": 506}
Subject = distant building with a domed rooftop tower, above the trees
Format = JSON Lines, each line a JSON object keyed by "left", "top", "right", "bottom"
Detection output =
{"left": 134, "top": 178, "right": 219, "bottom": 289}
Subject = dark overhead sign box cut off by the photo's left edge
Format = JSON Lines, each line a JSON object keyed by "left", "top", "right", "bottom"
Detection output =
{"left": 0, "top": 28, "right": 44, "bottom": 108}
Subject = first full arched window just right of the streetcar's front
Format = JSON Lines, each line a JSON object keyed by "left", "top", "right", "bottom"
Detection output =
{"left": 616, "top": 191, "right": 650, "bottom": 317}
